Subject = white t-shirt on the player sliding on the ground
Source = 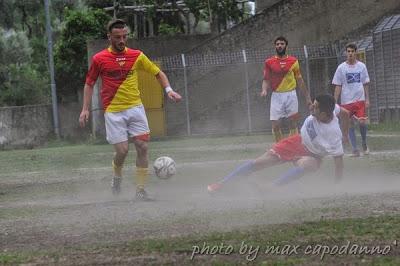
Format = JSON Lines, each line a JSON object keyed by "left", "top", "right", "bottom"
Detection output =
{"left": 300, "top": 104, "right": 344, "bottom": 157}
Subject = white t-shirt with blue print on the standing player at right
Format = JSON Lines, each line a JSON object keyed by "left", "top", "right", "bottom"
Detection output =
{"left": 332, "top": 61, "right": 369, "bottom": 104}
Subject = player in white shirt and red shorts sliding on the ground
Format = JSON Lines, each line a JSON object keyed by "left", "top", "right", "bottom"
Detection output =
{"left": 207, "top": 95, "right": 350, "bottom": 192}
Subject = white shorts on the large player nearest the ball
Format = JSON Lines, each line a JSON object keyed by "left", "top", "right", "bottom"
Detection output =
{"left": 104, "top": 105, "right": 150, "bottom": 144}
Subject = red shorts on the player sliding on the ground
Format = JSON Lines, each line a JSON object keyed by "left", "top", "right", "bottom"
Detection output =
{"left": 270, "top": 134, "right": 315, "bottom": 161}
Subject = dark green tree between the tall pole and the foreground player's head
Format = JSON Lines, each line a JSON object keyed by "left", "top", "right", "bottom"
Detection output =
{"left": 54, "top": 9, "right": 111, "bottom": 101}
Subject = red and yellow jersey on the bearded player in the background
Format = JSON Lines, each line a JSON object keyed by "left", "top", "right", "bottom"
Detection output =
{"left": 264, "top": 56, "right": 301, "bottom": 92}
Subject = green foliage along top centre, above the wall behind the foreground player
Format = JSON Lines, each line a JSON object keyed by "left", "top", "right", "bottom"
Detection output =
{"left": 86, "top": 0, "right": 244, "bottom": 38}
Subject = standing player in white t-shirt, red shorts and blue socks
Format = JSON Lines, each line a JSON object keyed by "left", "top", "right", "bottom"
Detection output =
{"left": 332, "top": 43, "right": 370, "bottom": 157}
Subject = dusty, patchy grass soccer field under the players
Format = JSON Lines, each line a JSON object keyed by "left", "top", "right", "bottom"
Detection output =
{"left": 0, "top": 130, "right": 400, "bottom": 265}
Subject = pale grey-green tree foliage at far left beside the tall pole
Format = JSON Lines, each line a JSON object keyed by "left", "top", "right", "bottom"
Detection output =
{"left": 0, "top": 0, "right": 74, "bottom": 105}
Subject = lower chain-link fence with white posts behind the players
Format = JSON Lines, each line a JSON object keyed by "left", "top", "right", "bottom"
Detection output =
{"left": 157, "top": 45, "right": 338, "bottom": 135}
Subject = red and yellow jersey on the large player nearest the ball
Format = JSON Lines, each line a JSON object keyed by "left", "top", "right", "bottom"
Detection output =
{"left": 86, "top": 48, "right": 160, "bottom": 112}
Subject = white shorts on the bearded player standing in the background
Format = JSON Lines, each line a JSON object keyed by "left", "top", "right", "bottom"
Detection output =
{"left": 269, "top": 90, "right": 299, "bottom": 120}
